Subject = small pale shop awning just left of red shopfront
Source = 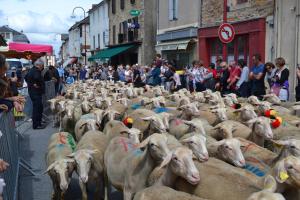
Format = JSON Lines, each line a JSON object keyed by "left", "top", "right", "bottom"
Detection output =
{"left": 155, "top": 39, "right": 193, "bottom": 52}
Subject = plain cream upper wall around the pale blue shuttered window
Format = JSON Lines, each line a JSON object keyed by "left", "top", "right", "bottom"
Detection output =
{"left": 157, "top": 0, "right": 201, "bottom": 34}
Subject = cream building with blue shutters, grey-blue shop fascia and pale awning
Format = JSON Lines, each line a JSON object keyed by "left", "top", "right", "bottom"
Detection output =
{"left": 156, "top": 0, "right": 202, "bottom": 66}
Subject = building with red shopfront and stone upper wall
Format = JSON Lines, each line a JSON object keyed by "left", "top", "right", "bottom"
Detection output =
{"left": 198, "top": 0, "right": 274, "bottom": 66}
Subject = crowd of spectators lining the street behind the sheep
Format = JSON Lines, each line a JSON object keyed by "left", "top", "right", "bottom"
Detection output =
{"left": 57, "top": 54, "right": 300, "bottom": 101}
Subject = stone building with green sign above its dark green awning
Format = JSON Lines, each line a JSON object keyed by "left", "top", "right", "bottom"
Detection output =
{"left": 108, "top": 0, "right": 157, "bottom": 65}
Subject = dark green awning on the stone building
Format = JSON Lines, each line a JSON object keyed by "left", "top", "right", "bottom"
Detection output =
{"left": 88, "top": 45, "right": 136, "bottom": 61}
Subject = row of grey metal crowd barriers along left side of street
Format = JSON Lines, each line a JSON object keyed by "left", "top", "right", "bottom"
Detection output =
{"left": 0, "top": 81, "right": 56, "bottom": 200}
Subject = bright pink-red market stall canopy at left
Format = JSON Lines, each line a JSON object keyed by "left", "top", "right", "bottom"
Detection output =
{"left": 8, "top": 42, "right": 53, "bottom": 55}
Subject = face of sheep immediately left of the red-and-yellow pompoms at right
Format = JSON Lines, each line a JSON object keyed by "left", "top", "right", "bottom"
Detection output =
{"left": 247, "top": 117, "right": 273, "bottom": 139}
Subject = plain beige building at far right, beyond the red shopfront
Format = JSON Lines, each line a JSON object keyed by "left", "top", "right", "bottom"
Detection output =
{"left": 274, "top": 0, "right": 300, "bottom": 100}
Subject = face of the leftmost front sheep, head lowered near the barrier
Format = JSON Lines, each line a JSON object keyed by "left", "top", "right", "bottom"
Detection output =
{"left": 47, "top": 159, "right": 75, "bottom": 192}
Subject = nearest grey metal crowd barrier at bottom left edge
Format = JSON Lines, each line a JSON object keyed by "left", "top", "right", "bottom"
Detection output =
{"left": 0, "top": 112, "right": 21, "bottom": 200}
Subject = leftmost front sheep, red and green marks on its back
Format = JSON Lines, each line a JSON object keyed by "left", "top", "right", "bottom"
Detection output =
{"left": 46, "top": 132, "right": 76, "bottom": 200}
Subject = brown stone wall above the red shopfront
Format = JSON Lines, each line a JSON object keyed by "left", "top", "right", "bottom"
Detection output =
{"left": 202, "top": 0, "right": 274, "bottom": 27}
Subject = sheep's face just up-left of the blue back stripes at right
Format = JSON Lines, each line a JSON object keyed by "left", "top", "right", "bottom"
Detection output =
{"left": 218, "top": 138, "right": 246, "bottom": 167}
